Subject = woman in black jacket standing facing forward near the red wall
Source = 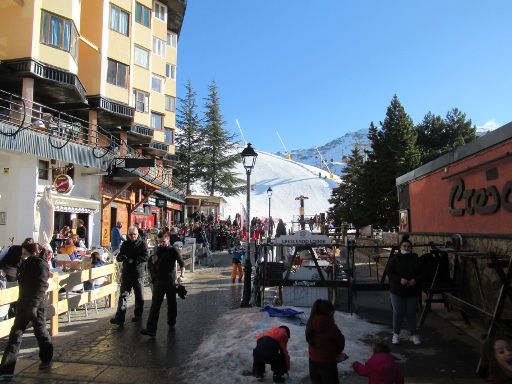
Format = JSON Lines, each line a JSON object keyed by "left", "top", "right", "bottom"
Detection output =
{"left": 388, "top": 240, "right": 421, "bottom": 345}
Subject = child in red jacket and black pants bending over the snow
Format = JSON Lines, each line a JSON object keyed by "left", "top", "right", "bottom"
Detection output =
{"left": 252, "top": 325, "right": 290, "bottom": 383}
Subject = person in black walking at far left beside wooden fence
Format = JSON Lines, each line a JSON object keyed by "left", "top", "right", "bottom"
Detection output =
{"left": 0, "top": 243, "right": 53, "bottom": 379}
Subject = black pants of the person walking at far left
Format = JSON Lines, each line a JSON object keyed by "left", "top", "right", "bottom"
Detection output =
{"left": 0, "top": 305, "right": 53, "bottom": 374}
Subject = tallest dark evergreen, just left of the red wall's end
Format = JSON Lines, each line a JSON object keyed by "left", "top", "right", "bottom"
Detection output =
{"left": 365, "top": 95, "right": 420, "bottom": 227}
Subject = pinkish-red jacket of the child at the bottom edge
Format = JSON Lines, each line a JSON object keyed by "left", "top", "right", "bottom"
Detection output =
{"left": 352, "top": 353, "right": 404, "bottom": 384}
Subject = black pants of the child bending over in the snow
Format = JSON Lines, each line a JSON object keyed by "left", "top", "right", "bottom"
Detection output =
{"left": 252, "top": 336, "right": 288, "bottom": 376}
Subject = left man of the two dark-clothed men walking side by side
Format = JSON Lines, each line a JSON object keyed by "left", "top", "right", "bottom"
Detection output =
{"left": 110, "top": 227, "right": 148, "bottom": 326}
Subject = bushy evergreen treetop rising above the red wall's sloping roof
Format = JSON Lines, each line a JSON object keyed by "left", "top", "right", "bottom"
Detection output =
{"left": 416, "top": 108, "right": 477, "bottom": 164}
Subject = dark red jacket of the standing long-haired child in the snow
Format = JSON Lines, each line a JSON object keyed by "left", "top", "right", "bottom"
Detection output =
{"left": 309, "top": 315, "right": 345, "bottom": 363}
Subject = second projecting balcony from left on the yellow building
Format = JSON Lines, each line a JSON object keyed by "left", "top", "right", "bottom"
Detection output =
{"left": 87, "top": 95, "right": 135, "bottom": 128}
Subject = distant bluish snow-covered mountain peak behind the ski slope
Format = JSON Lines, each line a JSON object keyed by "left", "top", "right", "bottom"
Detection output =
{"left": 276, "top": 129, "right": 369, "bottom": 175}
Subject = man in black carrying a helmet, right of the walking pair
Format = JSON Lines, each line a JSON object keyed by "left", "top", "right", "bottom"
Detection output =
{"left": 140, "top": 233, "right": 185, "bottom": 337}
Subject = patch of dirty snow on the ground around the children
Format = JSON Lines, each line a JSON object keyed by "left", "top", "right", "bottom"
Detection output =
{"left": 176, "top": 308, "right": 404, "bottom": 384}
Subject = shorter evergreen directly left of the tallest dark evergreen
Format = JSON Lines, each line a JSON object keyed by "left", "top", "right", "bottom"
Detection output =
{"left": 329, "top": 147, "right": 368, "bottom": 235}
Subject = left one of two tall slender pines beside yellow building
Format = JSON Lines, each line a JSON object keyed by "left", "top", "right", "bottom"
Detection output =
{"left": 173, "top": 80, "right": 201, "bottom": 194}
